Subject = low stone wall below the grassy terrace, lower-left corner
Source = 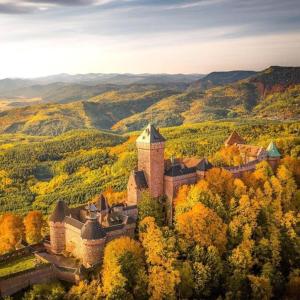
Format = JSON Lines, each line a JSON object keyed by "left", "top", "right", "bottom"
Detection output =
{"left": 0, "top": 264, "right": 56, "bottom": 297}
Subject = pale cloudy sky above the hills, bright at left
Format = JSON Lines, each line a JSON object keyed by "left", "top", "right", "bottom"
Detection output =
{"left": 0, "top": 0, "right": 300, "bottom": 78}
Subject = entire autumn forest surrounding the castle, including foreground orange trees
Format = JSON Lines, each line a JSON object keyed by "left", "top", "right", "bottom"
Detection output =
{"left": 0, "top": 120, "right": 300, "bottom": 300}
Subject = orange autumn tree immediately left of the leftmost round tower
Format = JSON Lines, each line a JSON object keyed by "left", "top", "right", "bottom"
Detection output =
{"left": 23, "top": 211, "right": 44, "bottom": 244}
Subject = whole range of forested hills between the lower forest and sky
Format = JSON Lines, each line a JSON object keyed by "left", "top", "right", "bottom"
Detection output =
{"left": 0, "top": 67, "right": 300, "bottom": 135}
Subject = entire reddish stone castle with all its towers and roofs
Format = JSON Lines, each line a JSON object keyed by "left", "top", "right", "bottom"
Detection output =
{"left": 49, "top": 124, "right": 280, "bottom": 267}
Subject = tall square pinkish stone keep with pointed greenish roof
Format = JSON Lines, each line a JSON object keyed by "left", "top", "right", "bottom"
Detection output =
{"left": 136, "top": 124, "right": 165, "bottom": 197}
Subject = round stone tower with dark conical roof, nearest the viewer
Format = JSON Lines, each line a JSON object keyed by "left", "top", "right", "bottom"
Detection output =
{"left": 81, "top": 214, "right": 106, "bottom": 268}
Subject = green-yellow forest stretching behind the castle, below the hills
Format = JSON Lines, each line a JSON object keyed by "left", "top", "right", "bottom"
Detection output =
{"left": 0, "top": 120, "right": 300, "bottom": 214}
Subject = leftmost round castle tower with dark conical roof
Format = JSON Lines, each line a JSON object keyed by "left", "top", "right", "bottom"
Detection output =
{"left": 49, "top": 200, "right": 68, "bottom": 254}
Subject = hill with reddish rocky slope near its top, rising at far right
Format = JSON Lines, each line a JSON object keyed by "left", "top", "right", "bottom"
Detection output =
{"left": 113, "top": 67, "right": 300, "bottom": 131}
